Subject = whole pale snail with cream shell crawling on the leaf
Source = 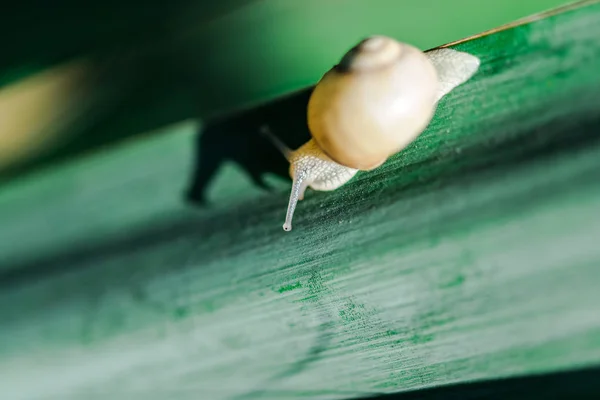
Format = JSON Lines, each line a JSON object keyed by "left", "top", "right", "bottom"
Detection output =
{"left": 261, "top": 36, "right": 480, "bottom": 231}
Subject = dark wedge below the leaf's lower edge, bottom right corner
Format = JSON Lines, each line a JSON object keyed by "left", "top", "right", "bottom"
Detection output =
{"left": 356, "top": 367, "right": 600, "bottom": 400}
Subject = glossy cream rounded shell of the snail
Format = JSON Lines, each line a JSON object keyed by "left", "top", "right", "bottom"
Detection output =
{"left": 307, "top": 36, "right": 439, "bottom": 170}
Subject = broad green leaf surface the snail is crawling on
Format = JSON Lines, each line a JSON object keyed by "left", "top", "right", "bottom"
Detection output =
{"left": 0, "top": 2, "right": 600, "bottom": 399}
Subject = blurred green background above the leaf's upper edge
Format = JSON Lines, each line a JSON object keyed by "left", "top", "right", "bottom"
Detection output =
{"left": 0, "top": 0, "right": 568, "bottom": 179}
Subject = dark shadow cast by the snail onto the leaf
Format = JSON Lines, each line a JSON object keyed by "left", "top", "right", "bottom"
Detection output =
{"left": 185, "top": 88, "right": 312, "bottom": 206}
